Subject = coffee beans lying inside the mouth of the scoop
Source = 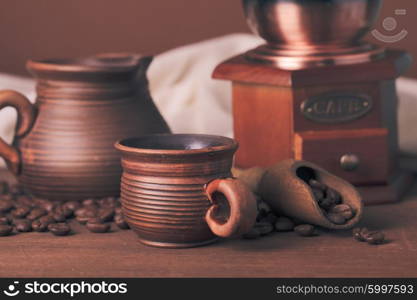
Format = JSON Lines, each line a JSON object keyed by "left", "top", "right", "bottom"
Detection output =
{"left": 308, "top": 179, "right": 355, "bottom": 225}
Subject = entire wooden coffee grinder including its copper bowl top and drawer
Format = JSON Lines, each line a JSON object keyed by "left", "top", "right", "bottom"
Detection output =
{"left": 213, "top": 0, "right": 412, "bottom": 204}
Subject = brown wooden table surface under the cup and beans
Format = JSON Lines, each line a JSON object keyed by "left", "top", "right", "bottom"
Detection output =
{"left": 0, "top": 172, "right": 417, "bottom": 277}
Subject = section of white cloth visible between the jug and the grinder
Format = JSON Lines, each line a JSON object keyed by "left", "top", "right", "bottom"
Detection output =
{"left": 148, "top": 34, "right": 262, "bottom": 137}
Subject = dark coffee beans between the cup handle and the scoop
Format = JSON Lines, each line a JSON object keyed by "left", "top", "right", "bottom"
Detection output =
{"left": 243, "top": 198, "right": 318, "bottom": 239}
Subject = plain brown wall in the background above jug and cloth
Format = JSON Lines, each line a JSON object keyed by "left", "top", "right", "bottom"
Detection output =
{"left": 0, "top": 0, "right": 417, "bottom": 77}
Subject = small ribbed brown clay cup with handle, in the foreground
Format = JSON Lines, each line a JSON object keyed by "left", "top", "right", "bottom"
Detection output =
{"left": 115, "top": 134, "right": 257, "bottom": 248}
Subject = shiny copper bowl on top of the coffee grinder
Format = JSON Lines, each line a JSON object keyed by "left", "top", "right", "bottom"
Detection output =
{"left": 243, "top": 0, "right": 382, "bottom": 50}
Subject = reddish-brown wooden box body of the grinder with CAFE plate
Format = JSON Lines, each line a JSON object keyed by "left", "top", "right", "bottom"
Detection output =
{"left": 213, "top": 50, "right": 412, "bottom": 204}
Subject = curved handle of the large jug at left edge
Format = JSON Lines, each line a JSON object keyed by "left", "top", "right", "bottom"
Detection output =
{"left": 0, "top": 90, "right": 36, "bottom": 175}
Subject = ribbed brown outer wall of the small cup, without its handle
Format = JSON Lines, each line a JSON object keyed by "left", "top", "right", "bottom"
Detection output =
{"left": 121, "top": 144, "right": 235, "bottom": 247}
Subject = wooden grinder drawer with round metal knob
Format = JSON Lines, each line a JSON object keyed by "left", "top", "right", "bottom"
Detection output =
{"left": 294, "top": 128, "right": 390, "bottom": 185}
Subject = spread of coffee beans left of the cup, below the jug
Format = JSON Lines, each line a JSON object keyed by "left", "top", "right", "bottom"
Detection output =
{"left": 0, "top": 182, "right": 129, "bottom": 236}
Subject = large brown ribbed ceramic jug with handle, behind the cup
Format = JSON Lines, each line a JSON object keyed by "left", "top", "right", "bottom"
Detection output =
{"left": 0, "top": 54, "right": 169, "bottom": 200}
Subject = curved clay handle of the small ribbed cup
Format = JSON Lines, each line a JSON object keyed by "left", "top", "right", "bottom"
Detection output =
{"left": 206, "top": 178, "right": 257, "bottom": 237}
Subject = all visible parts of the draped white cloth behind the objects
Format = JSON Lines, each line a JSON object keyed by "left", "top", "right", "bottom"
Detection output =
{"left": 0, "top": 34, "right": 417, "bottom": 168}
